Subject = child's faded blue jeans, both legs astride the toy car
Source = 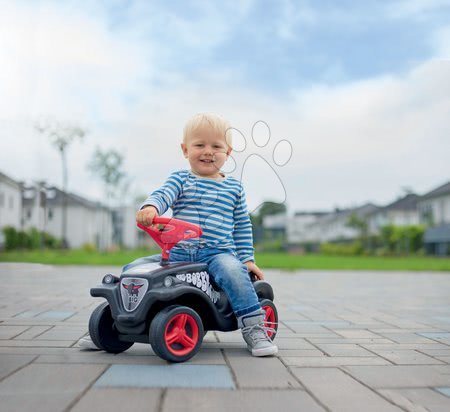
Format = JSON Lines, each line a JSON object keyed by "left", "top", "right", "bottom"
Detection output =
{"left": 124, "top": 247, "right": 261, "bottom": 317}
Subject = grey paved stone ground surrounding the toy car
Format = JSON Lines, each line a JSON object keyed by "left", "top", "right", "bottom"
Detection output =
{"left": 0, "top": 263, "right": 450, "bottom": 412}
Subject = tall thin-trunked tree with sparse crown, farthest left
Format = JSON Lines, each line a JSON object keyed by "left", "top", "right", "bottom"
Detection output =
{"left": 35, "top": 121, "right": 87, "bottom": 247}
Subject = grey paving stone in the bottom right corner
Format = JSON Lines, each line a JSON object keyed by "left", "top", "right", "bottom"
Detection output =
{"left": 378, "top": 388, "right": 450, "bottom": 412}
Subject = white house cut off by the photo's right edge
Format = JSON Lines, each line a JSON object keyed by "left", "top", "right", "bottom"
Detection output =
{"left": 417, "top": 182, "right": 450, "bottom": 256}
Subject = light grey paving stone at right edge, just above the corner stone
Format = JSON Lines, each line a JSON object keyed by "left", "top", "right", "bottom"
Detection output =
{"left": 344, "top": 365, "right": 450, "bottom": 388}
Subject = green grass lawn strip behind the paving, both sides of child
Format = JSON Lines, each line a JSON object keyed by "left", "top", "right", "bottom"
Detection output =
{"left": 0, "top": 249, "right": 450, "bottom": 271}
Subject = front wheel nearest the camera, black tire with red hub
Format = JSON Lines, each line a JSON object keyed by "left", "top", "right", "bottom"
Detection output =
{"left": 149, "top": 306, "right": 204, "bottom": 362}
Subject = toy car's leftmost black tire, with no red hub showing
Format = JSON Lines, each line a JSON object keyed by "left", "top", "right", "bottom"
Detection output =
{"left": 89, "top": 302, "right": 133, "bottom": 353}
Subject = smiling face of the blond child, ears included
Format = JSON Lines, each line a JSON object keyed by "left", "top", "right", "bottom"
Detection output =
{"left": 181, "top": 126, "right": 231, "bottom": 177}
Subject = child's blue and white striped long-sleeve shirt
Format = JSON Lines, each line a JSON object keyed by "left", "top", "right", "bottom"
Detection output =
{"left": 142, "top": 170, "right": 254, "bottom": 263}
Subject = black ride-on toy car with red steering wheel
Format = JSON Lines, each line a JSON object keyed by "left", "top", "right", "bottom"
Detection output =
{"left": 89, "top": 217, "right": 278, "bottom": 362}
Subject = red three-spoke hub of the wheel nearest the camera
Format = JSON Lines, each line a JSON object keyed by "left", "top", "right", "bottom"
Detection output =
{"left": 164, "top": 313, "right": 198, "bottom": 356}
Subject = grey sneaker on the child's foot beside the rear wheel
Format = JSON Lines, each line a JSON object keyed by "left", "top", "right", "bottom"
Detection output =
{"left": 238, "top": 311, "right": 278, "bottom": 356}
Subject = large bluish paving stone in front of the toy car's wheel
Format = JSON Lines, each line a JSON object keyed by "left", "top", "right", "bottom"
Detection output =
{"left": 95, "top": 364, "right": 234, "bottom": 389}
